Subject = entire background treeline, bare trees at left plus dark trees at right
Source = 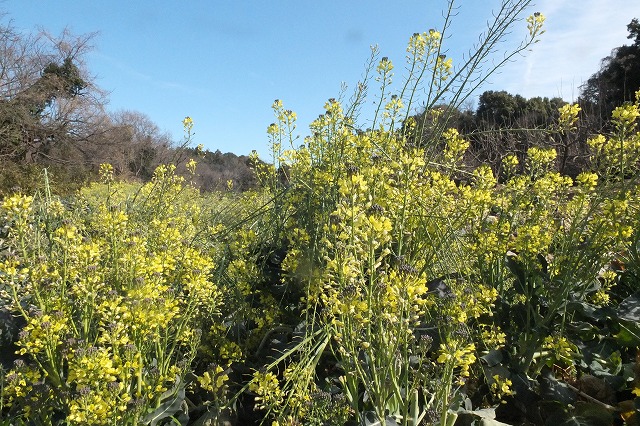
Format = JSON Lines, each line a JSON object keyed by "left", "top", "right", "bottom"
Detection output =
{"left": 0, "top": 14, "right": 640, "bottom": 196}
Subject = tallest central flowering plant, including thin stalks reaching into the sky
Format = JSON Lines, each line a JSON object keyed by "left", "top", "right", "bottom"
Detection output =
{"left": 242, "top": 1, "right": 544, "bottom": 425}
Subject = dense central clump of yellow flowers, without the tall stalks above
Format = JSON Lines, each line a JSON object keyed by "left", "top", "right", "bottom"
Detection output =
{"left": 252, "top": 84, "right": 504, "bottom": 417}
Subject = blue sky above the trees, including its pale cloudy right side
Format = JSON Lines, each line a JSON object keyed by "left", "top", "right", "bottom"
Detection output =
{"left": 0, "top": 0, "right": 640, "bottom": 157}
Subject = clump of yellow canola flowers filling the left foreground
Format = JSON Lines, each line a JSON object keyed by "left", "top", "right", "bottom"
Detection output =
{"left": 0, "top": 166, "right": 221, "bottom": 425}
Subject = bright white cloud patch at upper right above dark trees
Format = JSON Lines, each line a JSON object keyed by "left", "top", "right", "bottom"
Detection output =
{"left": 498, "top": 0, "right": 640, "bottom": 100}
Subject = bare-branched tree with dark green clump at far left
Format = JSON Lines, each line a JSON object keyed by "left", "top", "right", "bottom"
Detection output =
{"left": 0, "top": 19, "right": 106, "bottom": 163}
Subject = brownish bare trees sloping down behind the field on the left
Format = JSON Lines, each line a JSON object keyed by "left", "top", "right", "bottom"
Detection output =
{"left": 0, "top": 18, "right": 255, "bottom": 196}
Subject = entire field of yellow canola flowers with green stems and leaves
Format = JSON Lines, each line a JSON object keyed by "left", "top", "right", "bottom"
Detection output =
{"left": 0, "top": 4, "right": 640, "bottom": 426}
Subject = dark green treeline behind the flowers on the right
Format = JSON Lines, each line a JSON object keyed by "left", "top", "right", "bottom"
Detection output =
{"left": 410, "top": 18, "right": 640, "bottom": 176}
